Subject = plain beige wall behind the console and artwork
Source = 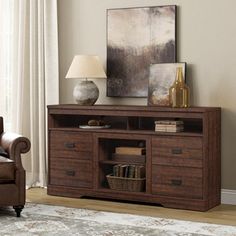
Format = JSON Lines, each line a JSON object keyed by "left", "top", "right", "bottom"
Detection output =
{"left": 58, "top": 0, "right": 236, "bottom": 189}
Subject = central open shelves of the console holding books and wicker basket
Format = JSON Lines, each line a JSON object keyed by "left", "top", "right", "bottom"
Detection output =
{"left": 98, "top": 135, "right": 146, "bottom": 191}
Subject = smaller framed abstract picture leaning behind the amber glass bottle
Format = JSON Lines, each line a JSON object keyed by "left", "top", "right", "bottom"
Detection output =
{"left": 148, "top": 62, "right": 187, "bottom": 106}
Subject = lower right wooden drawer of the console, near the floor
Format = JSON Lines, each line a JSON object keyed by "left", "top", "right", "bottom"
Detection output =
{"left": 152, "top": 165, "right": 203, "bottom": 199}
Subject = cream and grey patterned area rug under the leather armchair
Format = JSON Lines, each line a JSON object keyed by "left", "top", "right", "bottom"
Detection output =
{"left": 0, "top": 203, "right": 236, "bottom": 236}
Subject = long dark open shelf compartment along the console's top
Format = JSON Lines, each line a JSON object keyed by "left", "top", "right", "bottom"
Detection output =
{"left": 48, "top": 114, "right": 203, "bottom": 135}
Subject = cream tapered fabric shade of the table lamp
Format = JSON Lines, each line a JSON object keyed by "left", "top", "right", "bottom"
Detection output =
{"left": 66, "top": 55, "right": 107, "bottom": 78}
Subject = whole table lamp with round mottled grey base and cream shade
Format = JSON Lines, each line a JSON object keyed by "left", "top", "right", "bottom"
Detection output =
{"left": 66, "top": 55, "right": 107, "bottom": 106}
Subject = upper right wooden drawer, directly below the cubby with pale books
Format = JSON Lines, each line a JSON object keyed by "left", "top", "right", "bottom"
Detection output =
{"left": 152, "top": 137, "right": 203, "bottom": 168}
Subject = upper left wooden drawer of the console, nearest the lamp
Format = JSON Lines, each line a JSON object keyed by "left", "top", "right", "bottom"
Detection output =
{"left": 49, "top": 131, "right": 93, "bottom": 160}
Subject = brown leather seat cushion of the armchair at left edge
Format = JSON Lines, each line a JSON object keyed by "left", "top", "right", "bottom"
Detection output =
{"left": 0, "top": 156, "right": 16, "bottom": 184}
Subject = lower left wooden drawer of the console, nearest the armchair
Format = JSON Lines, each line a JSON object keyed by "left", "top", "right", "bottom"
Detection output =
{"left": 50, "top": 158, "right": 93, "bottom": 188}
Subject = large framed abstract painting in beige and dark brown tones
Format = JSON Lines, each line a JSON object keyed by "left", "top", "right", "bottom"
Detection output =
{"left": 107, "top": 5, "right": 176, "bottom": 97}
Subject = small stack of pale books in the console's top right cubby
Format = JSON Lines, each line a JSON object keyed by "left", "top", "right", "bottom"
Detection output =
{"left": 155, "top": 120, "right": 184, "bottom": 132}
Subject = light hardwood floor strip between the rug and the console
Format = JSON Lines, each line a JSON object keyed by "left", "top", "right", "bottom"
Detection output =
{"left": 26, "top": 188, "right": 236, "bottom": 226}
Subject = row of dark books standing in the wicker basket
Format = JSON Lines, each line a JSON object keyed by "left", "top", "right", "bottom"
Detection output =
{"left": 113, "top": 164, "right": 145, "bottom": 178}
